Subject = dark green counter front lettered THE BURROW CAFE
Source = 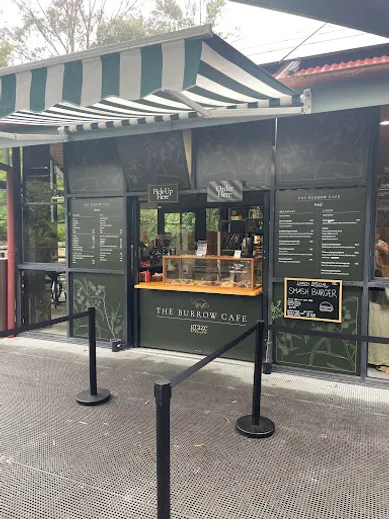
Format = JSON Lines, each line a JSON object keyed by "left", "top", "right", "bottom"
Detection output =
{"left": 139, "top": 290, "right": 262, "bottom": 360}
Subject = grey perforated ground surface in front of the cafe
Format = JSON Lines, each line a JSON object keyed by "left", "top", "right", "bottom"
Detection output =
{"left": 0, "top": 338, "right": 389, "bottom": 519}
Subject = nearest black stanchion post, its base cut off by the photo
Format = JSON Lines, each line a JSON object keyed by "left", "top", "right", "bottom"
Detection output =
{"left": 154, "top": 379, "right": 172, "bottom": 519}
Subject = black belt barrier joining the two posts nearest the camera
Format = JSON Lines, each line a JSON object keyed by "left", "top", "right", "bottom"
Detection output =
{"left": 154, "top": 321, "right": 275, "bottom": 519}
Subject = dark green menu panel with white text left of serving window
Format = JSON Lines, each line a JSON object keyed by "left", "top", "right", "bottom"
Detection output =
{"left": 70, "top": 198, "right": 124, "bottom": 270}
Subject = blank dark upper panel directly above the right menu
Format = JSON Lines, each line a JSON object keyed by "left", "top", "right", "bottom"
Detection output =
{"left": 276, "top": 109, "right": 372, "bottom": 187}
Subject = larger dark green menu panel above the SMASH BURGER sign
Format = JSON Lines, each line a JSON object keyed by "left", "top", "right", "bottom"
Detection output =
{"left": 274, "top": 188, "right": 365, "bottom": 281}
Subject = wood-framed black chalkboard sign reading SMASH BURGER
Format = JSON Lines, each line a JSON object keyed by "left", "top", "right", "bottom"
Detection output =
{"left": 284, "top": 278, "right": 342, "bottom": 323}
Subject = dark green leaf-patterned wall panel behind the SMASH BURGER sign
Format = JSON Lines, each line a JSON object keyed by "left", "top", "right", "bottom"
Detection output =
{"left": 273, "top": 284, "right": 362, "bottom": 375}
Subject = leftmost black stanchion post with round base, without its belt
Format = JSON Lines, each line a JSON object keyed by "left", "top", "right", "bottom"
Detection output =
{"left": 76, "top": 308, "right": 111, "bottom": 405}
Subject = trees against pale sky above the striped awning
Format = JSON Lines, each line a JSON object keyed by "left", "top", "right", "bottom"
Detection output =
{"left": 8, "top": 0, "right": 233, "bottom": 61}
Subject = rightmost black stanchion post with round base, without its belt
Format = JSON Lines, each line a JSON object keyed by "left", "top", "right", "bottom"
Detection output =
{"left": 236, "top": 321, "right": 275, "bottom": 438}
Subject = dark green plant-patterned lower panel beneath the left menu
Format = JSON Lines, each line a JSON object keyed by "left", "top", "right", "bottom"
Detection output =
{"left": 71, "top": 273, "right": 124, "bottom": 340}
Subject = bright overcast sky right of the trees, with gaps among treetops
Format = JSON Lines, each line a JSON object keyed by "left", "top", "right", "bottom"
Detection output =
{"left": 0, "top": 0, "right": 389, "bottom": 64}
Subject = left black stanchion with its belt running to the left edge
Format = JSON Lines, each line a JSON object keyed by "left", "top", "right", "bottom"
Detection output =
{"left": 0, "top": 308, "right": 111, "bottom": 406}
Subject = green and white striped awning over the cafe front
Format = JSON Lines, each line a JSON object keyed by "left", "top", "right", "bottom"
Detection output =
{"left": 0, "top": 26, "right": 304, "bottom": 132}
